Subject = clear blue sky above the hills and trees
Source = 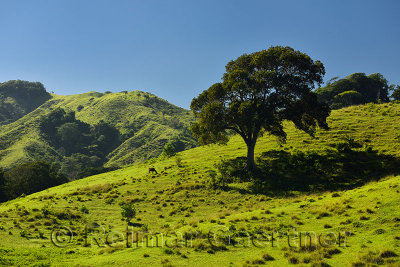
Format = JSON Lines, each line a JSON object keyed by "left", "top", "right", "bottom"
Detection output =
{"left": 0, "top": 0, "right": 400, "bottom": 108}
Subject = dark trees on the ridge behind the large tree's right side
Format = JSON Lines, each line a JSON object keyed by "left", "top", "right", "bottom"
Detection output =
{"left": 315, "top": 73, "right": 391, "bottom": 109}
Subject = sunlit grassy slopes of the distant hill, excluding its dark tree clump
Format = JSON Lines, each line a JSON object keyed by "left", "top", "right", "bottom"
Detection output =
{"left": 0, "top": 91, "right": 194, "bottom": 168}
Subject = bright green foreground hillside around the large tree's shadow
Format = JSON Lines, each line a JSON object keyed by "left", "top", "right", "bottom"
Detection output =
{"left": 0, "top": 101, "right": 400, "bottom": 266}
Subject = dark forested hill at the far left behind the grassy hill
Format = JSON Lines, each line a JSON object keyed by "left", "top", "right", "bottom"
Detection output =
{"left": 0, "top": 80, "right": 51, "bottom": 125}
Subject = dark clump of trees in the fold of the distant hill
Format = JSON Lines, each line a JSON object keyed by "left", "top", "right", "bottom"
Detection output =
{"left": 40, "top": 108, "right": 121, "bottom": 178}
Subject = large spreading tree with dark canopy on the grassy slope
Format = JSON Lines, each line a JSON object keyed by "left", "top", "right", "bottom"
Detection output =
{"left": 190, "top": 46, "right": 330, "bottom": 171}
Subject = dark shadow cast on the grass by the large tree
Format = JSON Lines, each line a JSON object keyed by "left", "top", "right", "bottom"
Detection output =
{"left": 219, "top": 149, "right": 400, "bottom": 195}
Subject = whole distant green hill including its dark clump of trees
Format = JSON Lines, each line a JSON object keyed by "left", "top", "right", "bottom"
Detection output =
{"left": 0, "top": 86, "right": 197, "bottom": 176}
